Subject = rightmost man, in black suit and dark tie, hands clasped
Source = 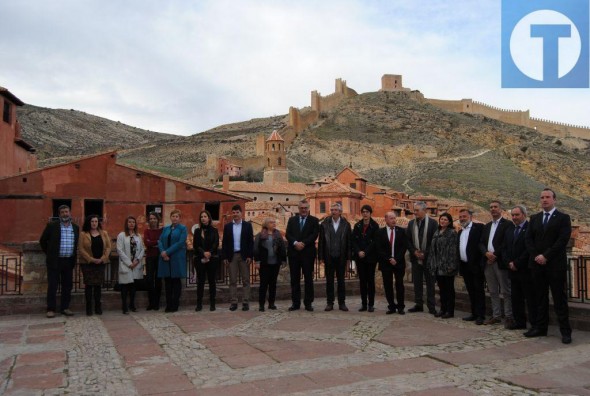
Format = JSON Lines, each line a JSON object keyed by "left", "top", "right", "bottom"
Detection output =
{"left": 524, "top": 188, "right": 572, "bottom": 344}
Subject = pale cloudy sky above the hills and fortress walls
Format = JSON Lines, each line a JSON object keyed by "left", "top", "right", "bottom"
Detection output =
{"left": 0, "top": 0, "right": 590, "bottom": 135}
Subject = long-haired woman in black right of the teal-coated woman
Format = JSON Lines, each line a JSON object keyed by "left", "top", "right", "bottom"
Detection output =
{"left": 193, "top": 210, "right": 219, "bottom": 311}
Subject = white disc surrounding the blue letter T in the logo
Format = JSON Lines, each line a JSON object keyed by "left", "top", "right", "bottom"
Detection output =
{"left": 510, "top": 10, "right": 582, "bottom": 81}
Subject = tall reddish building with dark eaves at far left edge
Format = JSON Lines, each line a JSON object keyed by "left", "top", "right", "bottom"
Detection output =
{"left": 0, "top": 87, "right": 37, "bottom": 177}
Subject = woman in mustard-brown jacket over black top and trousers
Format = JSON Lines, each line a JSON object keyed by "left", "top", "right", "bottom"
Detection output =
{"left": 78, "top": 215, "right": 111, "bottom": 316}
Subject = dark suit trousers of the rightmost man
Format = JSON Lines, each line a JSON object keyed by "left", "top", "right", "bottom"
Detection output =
{"left": 532, "top": 268, "right": 572, "bottom": 335}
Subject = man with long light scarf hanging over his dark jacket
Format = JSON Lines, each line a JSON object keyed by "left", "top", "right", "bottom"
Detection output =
{"left": 406, "top": 202, "right": 438, "bottom": 315}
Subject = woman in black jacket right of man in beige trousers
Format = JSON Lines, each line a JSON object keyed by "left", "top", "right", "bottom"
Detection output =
{"left": 254, "top": 217, "right": 287, "bottom": 312}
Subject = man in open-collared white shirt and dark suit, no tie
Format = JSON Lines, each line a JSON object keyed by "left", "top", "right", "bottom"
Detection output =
{"left": 459, "top": 209, "right": 486, "bottom": 325}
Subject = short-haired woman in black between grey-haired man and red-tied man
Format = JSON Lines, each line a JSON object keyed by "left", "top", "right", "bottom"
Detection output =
{"left": 352, "top": 205, "right": 379, "bottom": 312}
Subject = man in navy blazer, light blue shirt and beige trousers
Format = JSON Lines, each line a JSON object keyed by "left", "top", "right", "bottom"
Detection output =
{"left": 222, "top": 205, "right": 254, "bottom": 311}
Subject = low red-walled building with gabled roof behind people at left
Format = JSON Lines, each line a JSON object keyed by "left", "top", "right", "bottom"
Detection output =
{"left": 0, "top": 152, "right": 250, "bottom": 245}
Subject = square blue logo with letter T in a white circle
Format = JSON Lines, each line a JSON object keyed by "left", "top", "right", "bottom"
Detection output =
{"left": 502, "top": 0, "right": 589, "bottom": 88}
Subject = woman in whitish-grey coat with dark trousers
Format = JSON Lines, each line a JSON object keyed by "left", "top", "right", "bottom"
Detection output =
{"left": 117, "top": 216, "right": 145, "bottom": 314}
